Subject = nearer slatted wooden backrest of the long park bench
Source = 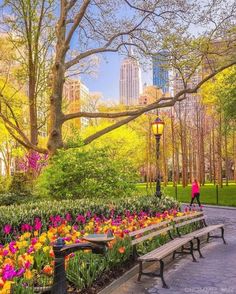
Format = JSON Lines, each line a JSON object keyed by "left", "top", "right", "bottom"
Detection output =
{"left": 129, "top": 220, "right": 173, "bottom": 245}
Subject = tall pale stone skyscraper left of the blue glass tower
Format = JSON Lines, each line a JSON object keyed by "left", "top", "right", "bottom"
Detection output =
{"left": 120, "top": 57, "right": 141, "bottom": 106}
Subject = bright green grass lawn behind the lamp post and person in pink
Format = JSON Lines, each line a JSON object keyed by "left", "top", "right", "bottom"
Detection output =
{"left": 137, "top": 183, "right": 236, "bottom": 206}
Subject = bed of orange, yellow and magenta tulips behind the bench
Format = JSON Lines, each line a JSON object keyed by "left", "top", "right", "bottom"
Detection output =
{"left": 0, "top": 204, "right": 197, "bottom": 293}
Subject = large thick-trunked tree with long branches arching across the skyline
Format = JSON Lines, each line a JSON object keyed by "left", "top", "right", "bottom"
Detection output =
{"left": 0, "top": 0, "right": 236, "bottom": 155}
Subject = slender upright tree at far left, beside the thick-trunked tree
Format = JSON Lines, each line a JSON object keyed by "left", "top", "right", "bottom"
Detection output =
{"left": 2, "top": 0, "right": 55, "bottom": 146}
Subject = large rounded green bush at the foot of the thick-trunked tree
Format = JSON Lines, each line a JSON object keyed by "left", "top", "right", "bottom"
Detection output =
{"left": 36, "top": 148, "right": 136, "bottom": 200}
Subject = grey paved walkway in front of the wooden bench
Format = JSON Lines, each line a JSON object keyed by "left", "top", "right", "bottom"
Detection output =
{"left": 111, "top": 208, "right": 236, "bottom": 294}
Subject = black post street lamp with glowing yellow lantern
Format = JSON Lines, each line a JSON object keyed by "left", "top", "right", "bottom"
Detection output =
{"left": 152, "top": 117, "right": 164, "bottom": 198}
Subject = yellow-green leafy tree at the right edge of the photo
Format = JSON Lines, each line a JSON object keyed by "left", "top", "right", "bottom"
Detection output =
{"left": 202, "top": 66, "right": 236, "bottom": 185}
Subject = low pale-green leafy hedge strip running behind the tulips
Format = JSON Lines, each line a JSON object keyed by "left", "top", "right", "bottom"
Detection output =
{"left": 0, "top": 196, "right": 179, "bottom": 243}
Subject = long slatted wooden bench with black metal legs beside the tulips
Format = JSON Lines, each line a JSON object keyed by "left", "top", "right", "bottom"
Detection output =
{"left": 129, "top": 212, "right": 226, "bottom": 288}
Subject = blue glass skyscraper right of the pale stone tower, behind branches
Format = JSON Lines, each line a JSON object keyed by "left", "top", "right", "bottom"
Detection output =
{"left": 152, "top": 51, "right": 169, "bottom": 93}
